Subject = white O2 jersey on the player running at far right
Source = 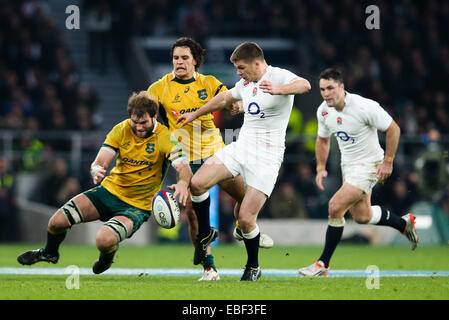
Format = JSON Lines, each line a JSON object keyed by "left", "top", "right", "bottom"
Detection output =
{"left": 316, "top": 91, "right": 393, "bottom": 164}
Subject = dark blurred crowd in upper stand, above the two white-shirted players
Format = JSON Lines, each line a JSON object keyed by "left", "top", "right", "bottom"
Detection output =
{"left": 103, "top": 0, "right": 449, "bottom": 134}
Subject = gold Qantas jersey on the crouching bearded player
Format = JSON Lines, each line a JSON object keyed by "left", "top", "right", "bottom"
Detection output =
{"left": 101, "top": 119, "right": 187, "bottom": 211}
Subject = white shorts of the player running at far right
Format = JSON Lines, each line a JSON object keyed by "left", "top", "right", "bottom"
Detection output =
{"left": 341, "top": 160, "right": 382, "bottom": 194}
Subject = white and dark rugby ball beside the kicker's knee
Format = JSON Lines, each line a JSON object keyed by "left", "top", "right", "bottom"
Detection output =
{"left": 151, "top": 190, "right": 181, "bottom": 229}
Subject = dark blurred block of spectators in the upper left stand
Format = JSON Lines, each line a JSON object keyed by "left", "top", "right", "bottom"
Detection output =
{"left": 0, "top": 0, "right": 98, "bottom": 131}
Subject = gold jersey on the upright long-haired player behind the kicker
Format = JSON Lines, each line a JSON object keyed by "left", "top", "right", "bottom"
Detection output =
{"left": 148, "top": 73, "right": 227, "bottom": 161}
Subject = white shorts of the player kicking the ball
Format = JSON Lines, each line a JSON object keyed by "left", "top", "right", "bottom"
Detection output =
{"left": 214, "top": 142, "right": 282, "bottom": 197}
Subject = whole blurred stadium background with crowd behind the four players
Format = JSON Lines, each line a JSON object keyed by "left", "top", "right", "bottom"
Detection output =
{"left": 0, "top": 0, "right": 449, "bottom": 249}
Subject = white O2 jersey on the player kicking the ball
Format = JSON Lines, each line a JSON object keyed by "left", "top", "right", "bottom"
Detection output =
{"left": 230, "top": 66, "right": 302, "bottom": 157}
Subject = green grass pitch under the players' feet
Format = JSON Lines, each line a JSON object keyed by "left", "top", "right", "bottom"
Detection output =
{"left": 0, "top": 244, "right": 449, "bottom": 300}
